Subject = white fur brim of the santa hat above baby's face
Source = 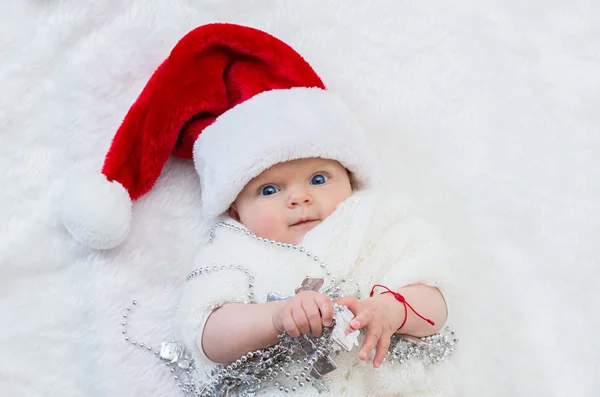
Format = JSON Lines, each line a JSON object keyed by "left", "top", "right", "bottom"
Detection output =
{"left": 194, "top": 88, "right": 376, "bottom": 217}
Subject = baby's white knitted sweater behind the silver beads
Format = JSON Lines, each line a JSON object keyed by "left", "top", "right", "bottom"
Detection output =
{"left": 179, "top": 192, "right": 455, "bottom": 397}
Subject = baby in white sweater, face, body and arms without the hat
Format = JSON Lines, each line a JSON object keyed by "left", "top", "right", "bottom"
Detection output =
{"left": 179, "top": 151, "right": 452, "bottom": 396}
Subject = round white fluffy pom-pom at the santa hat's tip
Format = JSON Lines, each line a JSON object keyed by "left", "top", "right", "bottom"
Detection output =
{"left": 60, "top": 174, "right": 131, "bottom": 249}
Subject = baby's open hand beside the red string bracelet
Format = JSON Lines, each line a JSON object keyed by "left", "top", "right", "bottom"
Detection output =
{"left": 336, "top": 294, "right": 404, "bottom": 368}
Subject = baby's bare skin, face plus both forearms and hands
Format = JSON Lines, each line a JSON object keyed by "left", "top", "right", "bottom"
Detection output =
{"left": 201, "top": 158, "right": 446, "bottom": 367}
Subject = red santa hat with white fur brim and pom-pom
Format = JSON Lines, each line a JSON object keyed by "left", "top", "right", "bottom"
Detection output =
{"left": 60, "top": 23, "right": 374, "bottom": 249}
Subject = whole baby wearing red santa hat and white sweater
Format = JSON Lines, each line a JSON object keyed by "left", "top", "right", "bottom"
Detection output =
{"left": 61, "top": 24, "right": 454, "bottom": 396}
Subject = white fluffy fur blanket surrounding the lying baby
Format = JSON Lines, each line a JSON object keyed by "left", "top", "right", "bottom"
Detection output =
{"left": 0, "top": 0, "right": 600, "bottom": 397}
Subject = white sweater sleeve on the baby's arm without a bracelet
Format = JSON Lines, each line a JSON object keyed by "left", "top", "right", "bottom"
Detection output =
{"left": 177, "top": 267, "right": 250, "bottom": 368}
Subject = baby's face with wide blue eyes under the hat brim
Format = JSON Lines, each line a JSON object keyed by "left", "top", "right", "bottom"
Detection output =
{"left": 229, "top": 158, "right": 352, "bottom": 244}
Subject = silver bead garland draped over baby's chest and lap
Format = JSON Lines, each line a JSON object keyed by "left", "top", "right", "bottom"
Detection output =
{"left": 121, "top": 222, "right": 458, "bottom": 397}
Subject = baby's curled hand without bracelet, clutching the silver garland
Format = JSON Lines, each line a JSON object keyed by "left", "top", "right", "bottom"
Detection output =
{"left": 273, "top": 291, "right": 333, "bottom": 337}
